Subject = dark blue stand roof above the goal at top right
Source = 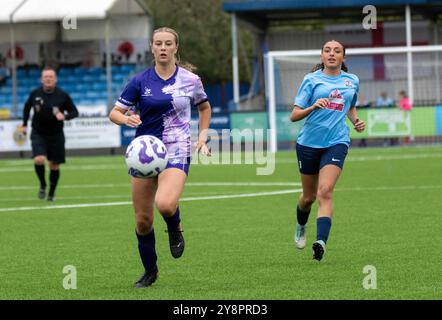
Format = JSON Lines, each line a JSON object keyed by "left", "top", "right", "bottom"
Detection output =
{"left": 223, "top": 0, "right": 442, "bottom": 30}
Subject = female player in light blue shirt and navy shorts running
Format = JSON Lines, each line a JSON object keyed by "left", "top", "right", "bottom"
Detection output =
{"left": 290, "top": 40, "right": 365, "bottom": 261}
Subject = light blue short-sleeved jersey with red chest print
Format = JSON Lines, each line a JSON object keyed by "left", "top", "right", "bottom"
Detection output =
{"left": 295, "top": 70, "right": 359, "bottom": 148}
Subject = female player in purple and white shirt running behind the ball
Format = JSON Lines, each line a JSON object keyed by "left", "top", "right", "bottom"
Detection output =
{"left": 109, "top": 27, "right": 211, "bottom": 288}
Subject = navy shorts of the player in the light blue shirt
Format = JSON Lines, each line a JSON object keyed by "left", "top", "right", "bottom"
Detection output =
{"left": 296, "top": 143, "right": 348, "bottom": 174}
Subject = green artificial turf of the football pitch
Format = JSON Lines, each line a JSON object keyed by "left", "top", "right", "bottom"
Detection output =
{"left": 0, "top": 147, "right": 442, "bottom": 300}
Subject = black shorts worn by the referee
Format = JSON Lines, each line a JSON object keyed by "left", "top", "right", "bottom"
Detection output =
{"left": 31, "top": 130, "right": 66, "bottom": 164}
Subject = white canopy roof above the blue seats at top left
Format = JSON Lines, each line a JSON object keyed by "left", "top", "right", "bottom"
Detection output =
{"left": 0, "top": 0, "right": 148, "bottom": 23}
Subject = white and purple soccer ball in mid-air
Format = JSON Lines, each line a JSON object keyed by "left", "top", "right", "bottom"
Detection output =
{"left": 126, "top": 135, "right": 168, "bottom": 178}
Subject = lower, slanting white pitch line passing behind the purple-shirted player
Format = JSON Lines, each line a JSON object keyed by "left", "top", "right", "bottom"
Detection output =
{"left": 0, "top": 189, "right": 302, "bottom": 212}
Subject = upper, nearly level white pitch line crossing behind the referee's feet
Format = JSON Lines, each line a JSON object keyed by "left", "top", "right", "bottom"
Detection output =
{"left": 0, "top": 181, "right": 301, "bottom": 190}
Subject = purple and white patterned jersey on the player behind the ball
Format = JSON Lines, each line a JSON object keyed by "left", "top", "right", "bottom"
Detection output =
{"left": 116, "top": 67, "right": 208, "bottom": 158}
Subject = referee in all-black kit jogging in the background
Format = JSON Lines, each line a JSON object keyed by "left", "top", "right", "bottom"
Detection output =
{"left": 23, "top": 67, "right": 78, "bottom": 201}
